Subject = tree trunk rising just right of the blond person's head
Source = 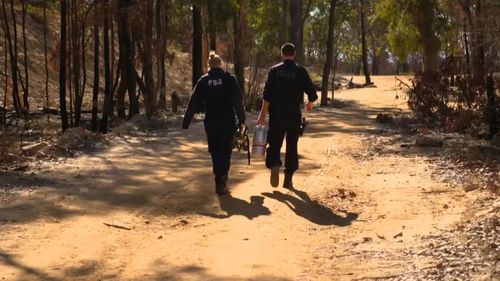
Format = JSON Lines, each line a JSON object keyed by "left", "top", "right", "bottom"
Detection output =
{"left": 233, "top": 0, "right": 246, "bottom": 97}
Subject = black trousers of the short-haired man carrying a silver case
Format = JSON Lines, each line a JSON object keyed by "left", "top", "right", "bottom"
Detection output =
{"left": 266, "top": 122, "right": 300, "bottom": 173}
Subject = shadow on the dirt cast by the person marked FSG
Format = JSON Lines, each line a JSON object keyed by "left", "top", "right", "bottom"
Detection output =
{"left": 199, "top": 194, "right": 271, "bottom": 220}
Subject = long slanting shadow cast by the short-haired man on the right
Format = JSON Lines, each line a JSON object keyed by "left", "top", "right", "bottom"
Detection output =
{"left": 262, "top": 189, "right": 359, "bottom": 226}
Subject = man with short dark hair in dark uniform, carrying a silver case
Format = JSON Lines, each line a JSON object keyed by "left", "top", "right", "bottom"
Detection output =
{"left": 257, "top": 43, "right": 318, "bottom": 189}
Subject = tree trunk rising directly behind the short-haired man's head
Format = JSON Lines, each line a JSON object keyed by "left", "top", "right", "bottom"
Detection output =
{"left": 290, "top": 0, "right": 304, "bottom": 64}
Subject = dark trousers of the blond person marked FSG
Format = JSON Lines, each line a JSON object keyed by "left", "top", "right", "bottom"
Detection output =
{"left": 204, "top": 121, "right": 236, "bottom": 178}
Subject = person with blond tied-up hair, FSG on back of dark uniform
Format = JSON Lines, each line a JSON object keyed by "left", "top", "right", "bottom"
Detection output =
{"left": 182, "top": 53, "right": 246, "bottom": 195}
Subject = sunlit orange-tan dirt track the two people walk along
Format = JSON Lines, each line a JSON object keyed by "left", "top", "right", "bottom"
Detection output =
{"left": 0, "top": 77, "right": 492, "bottom": 280}
